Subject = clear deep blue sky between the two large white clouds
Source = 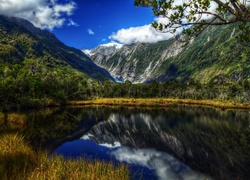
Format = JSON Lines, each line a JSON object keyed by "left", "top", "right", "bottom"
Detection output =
{"left": 53, "top": 0, "right": 155, "bottom": 49}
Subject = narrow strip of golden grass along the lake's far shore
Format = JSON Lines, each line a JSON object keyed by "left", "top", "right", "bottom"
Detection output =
{"left": 67, "top": 98, "right": 250, "bottom": 109}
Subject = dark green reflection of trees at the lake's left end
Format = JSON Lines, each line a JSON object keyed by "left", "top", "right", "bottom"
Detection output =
{"left": 24, "top": 109, "right": 94, "bottom": 148}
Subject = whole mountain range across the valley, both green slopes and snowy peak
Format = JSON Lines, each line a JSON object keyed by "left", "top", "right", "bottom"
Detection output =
{"left": 0, "top": 16, "right": 250, "bottom": 84}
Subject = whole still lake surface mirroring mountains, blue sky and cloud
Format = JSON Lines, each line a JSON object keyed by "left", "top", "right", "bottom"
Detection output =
{"left": 24, "top": 106, "right": 250, "bottom": 180}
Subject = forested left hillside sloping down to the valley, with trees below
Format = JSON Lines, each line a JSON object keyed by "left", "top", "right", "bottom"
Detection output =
{"left": 0, "top": 16, "right": 113, "bottom": 109}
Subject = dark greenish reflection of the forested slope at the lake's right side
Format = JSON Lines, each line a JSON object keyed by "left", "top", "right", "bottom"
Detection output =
{"left": 156, "top": 108, "right": 250, "bottom": 179}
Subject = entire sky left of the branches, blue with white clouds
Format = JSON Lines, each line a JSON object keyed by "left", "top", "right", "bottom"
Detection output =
{"left": 0, "top": 0, "right": 172, "bottom": 49}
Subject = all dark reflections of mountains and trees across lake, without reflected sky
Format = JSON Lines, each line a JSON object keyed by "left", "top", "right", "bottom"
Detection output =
{"left": 24, "top": 106, "right": 250, "bottom": 180}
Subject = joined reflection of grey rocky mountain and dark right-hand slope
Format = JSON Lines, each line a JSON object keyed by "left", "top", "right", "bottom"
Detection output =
{"left": 82, "top": 108, "right": 250, "bottom": 179}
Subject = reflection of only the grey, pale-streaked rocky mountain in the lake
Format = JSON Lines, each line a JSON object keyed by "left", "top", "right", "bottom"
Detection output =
{"left": 83, "top": 113, "right": 185, "bottom": 157}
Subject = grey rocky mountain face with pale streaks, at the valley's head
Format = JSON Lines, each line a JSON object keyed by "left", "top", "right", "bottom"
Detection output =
{"left": 84, "top": 40, "right": 182, "bottom": 83}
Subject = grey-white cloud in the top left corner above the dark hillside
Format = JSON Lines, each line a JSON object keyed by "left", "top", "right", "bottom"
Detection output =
{"left": 0, "top": 0, "right": 76, "bottom": 30}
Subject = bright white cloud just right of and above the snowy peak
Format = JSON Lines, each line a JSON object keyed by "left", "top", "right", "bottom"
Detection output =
{"left": 109, "top": 25, "right": 176, "bottom": 44}
